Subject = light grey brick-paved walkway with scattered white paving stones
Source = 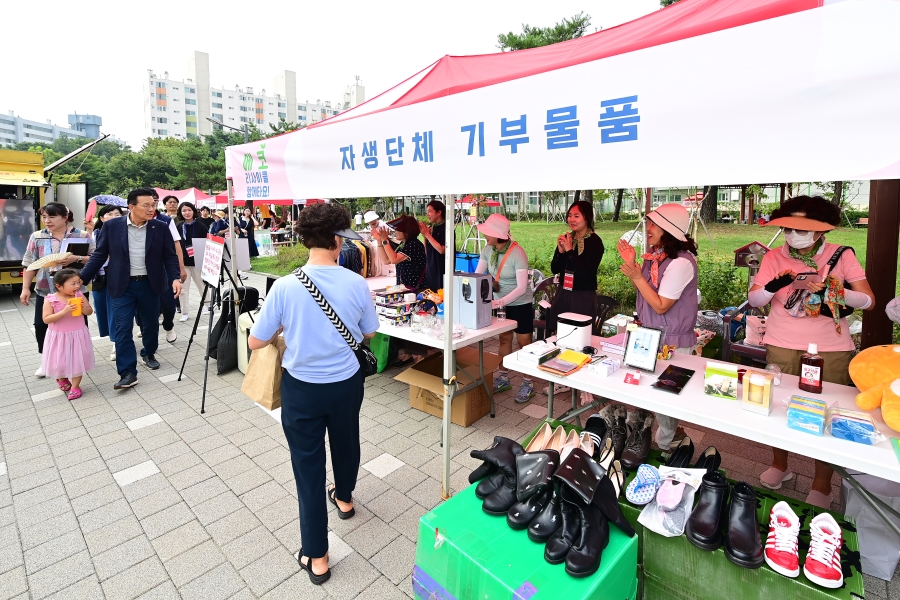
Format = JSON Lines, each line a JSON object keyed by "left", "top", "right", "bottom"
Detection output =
{"left": 0, "top": 276, "right": 900, "bottom": 600}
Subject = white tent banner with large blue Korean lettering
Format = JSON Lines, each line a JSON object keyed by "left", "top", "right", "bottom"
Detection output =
{"left": 226, "top": 0, "right": 900, "bottom": 200}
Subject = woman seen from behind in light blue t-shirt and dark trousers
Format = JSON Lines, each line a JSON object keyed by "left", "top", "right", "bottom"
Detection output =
{"left": 249, "top": 204, "right": 378, "bottom": 585}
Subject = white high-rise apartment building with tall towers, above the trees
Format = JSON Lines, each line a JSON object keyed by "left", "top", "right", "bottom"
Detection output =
{"left": 144, "top": 51, "right": 365, "bottom": 139}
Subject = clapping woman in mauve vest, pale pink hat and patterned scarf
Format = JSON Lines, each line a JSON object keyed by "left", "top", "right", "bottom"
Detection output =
{"left": 616, "top": 204, "right": 698, "bottom": 450}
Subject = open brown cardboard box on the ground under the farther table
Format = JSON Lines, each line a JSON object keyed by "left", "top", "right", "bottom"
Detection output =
{"left": 394, "top": 348, "right": 500, "bottom": 427}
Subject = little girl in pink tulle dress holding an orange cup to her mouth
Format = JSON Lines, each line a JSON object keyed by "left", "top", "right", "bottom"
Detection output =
{"left": 41, "top": 269, "right": 94, "bottom": 400}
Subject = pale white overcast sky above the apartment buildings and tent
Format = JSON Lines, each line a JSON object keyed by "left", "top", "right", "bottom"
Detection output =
{"left": 0, "top": 0, "right": 659, "bottom": 149}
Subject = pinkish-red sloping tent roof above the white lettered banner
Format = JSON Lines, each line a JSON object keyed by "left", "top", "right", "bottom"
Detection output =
{"left": 318, "top": 0, "right": 823, "bottom": 129}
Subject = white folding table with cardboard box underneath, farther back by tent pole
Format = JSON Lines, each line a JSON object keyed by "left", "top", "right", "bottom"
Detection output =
{"left": 378, "top": 317, "right": 516, "bottom": 490}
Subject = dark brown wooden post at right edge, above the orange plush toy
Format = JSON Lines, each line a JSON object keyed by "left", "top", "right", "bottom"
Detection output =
{"left": 862, "top": 179, "right": 900, "bottom": 348}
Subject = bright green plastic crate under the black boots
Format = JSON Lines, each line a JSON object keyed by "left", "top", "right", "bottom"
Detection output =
{"left": 413, "top": 485, "right": 638, "bottom": 600}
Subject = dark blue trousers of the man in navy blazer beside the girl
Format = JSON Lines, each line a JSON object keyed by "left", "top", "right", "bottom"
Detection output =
{"left": 110, "top": 279, "right": 159, "bottom": 377}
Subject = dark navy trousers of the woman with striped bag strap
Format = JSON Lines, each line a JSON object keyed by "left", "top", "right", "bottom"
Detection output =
{"left": 281, "top": 369, "right": 365, "bottom": 558}
